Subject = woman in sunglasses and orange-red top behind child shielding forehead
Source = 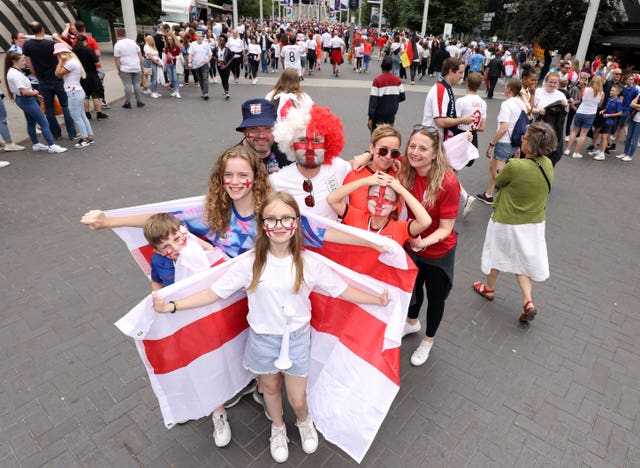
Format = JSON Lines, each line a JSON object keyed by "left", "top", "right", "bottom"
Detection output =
{"left": 344, "top": 124, "right": 402, "bottom": 212}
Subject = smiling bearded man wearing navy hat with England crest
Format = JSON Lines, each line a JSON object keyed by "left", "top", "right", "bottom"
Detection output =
{"left": 236, "top": 99, "right": 291, "bottom": 173}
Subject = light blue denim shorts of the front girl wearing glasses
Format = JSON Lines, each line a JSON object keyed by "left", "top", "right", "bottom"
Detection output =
{"left": 243, "top": 324, "right": 311, "bottom": 377}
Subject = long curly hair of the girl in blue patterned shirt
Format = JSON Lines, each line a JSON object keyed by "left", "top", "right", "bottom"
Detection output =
{"left": 204, "top": 145, "right": 271, "bottom": 236}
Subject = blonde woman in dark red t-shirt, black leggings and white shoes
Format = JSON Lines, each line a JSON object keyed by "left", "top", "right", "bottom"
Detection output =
{"left": 399, "top": 125, "right": 460, "bottom": 366}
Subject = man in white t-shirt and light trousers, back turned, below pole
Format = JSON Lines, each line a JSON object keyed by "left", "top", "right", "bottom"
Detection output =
{"left": 113, "top": 28, "right": 144, "bottom": 109}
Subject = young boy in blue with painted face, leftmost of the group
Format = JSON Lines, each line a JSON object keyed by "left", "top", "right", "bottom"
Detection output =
{"left": 143, "top": 213, "right": 214, "bottom": 291}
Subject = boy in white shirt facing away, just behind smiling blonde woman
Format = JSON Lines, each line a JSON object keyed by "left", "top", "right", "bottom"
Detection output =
{"left": 456, "top": 72, "right": 487, "bottom": 217}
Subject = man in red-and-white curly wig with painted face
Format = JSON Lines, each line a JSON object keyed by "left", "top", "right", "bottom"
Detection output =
{"left": 270, "top": 104, "right": 351, "bottom": 220}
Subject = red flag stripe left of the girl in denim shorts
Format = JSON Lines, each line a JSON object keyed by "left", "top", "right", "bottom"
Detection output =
{"left": 143, "top": 297, "right": 249, "bottom": 374}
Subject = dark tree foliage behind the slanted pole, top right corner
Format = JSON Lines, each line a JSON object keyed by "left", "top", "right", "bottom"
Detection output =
{"left": 512, "top": 0, "right": 622, "bottom": 53}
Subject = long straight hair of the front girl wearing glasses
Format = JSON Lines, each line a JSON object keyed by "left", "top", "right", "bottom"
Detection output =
{"left": 247, "top": 192, "right": 304, "bottom": 293}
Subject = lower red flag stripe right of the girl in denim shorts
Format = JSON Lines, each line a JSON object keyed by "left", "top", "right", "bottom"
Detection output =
{"left": 311, "top": 293, "right": 400, "bottom": 385}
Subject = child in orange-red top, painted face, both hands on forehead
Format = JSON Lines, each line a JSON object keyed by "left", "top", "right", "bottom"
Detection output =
{"left": 327, "top": 172, "right": 431, "bottom": 245}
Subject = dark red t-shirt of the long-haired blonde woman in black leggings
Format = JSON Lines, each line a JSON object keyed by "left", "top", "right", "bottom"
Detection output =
{"left": 409, "top": 172, "right": 460, "bottom": 258}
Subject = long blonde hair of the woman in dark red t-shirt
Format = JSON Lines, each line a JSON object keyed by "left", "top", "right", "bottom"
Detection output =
{"left": 398, "top": 128, "right": 451, "bottom": 208}
